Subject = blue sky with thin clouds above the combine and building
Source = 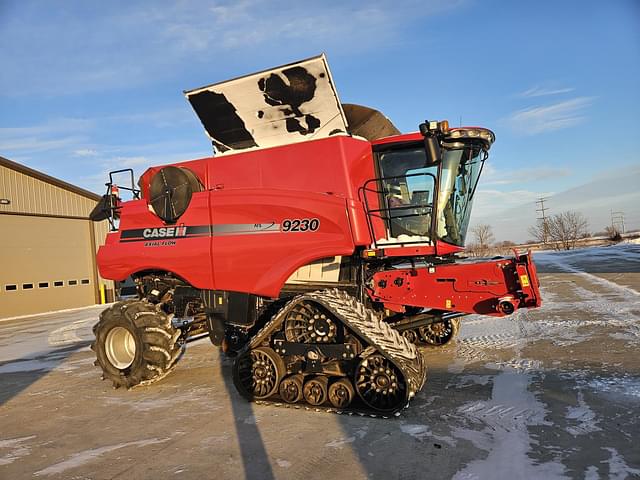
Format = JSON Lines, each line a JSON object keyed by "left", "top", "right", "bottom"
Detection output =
{"left": 0, "top": 0, "right": 640, "bottom": 240}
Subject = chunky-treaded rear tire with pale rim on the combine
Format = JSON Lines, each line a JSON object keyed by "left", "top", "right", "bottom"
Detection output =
{"left": 91, "top": 300, "right": 183, "bottom": 388}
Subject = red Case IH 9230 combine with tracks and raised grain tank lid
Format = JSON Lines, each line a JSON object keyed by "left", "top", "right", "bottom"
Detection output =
{"left": 92, "top": 56, "right": 540, "bottom": 415}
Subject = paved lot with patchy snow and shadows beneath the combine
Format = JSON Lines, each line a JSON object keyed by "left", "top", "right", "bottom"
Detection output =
{"left": 0, "top": 246, "right": 640, "bottom": 479}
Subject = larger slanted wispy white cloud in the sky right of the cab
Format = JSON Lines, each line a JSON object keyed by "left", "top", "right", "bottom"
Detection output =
{"left": 506, "top": 97, "right": 593, "bottom": 135}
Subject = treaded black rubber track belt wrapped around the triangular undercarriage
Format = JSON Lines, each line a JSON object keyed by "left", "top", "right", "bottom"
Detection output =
{"left": 238, "top": 289, "right": 427, "bottom": 416}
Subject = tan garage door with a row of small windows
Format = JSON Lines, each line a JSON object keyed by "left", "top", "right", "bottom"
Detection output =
{"left": 0, "top": 215, "right": 95, "bottom": 318}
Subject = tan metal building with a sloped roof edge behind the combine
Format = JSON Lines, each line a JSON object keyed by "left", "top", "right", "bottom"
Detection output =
{"left": 0, "top": 157, "right": 113, "bottom": 318}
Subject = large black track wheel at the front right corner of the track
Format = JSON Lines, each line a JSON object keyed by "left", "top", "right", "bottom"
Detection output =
{"left": 355, "top": 353, "right": 406, "bottom": 412}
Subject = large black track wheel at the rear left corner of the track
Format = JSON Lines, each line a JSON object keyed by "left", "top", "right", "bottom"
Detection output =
{"left": 233, "top": 347, "right": 285, "bottom": 401}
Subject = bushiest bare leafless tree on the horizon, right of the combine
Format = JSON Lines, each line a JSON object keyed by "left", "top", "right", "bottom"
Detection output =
{"left": 529, "top": 210, "right": 589, "bottom": 250}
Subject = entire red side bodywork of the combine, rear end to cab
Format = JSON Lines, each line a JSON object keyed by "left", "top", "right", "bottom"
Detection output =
{"left": 98, "top": 136, "right": 384, "bottom": 297}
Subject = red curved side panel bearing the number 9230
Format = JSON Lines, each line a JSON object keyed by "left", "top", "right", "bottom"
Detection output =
{"left": 212, "top": 189, "right": 355, "bottom": 297}
